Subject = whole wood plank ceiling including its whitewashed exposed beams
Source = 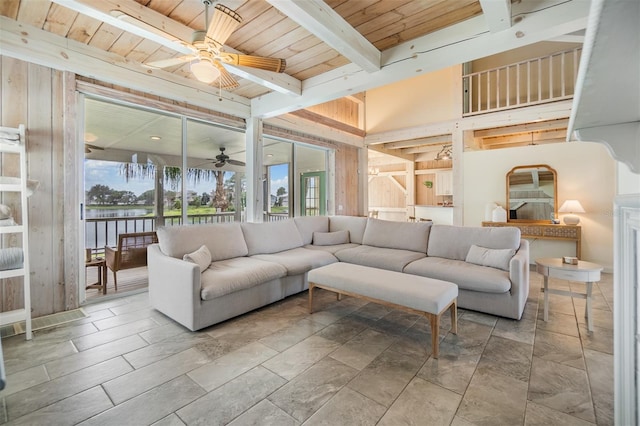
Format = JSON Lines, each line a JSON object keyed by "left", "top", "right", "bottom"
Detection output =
{"left": 0, "top": 0, "right": 589, "bottom": 158}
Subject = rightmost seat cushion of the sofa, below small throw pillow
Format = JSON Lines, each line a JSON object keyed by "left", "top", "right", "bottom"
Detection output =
{"left": 403, "top": 257, "right": 511, "bottom": 293}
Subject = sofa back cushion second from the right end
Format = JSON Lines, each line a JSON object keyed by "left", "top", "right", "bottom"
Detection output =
{"left": 362, "top": 218, "right": 431, "bottom": 254}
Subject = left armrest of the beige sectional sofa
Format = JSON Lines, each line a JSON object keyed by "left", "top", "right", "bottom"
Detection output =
{"left": 147, "top": 244, "right": 200, "bottom": 331}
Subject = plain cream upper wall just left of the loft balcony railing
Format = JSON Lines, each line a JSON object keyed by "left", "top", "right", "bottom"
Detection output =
{"left": 365, "top": 66, "right": 462, "bottom": 133}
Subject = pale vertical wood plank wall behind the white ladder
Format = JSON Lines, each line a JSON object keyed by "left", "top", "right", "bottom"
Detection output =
{"left": 0, "top": 56, "right": 68, "bottom": 317}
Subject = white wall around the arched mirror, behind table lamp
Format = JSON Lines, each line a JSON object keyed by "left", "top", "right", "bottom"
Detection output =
{"left": 463, "top": 142, "right": 616, "bottom": 272}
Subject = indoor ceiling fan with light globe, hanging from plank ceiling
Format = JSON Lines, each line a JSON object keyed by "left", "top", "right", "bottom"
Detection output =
{"left": 145, "top": 0, "right": 286, "bottom": 89}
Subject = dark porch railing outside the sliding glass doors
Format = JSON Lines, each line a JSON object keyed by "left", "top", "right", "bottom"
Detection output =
{"left": 85, "top": 212, "right": 235, "bottom": 252}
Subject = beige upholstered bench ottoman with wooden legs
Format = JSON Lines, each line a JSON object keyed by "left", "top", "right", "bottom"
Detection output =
{"left": 308, "top": 262, "right": 458, "bottom": 358}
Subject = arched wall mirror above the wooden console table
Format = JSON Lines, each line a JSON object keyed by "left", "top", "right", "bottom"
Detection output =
{"left": 507, "top": 164, "right": 558, "bottom": 223}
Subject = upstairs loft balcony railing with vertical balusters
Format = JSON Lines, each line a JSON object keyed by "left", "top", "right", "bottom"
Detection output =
{"left": 462, "top": 48, "right": 582, "bottom": 117}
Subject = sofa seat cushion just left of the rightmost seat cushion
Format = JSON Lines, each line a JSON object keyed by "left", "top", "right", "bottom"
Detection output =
{"left": 335, "top": 245, "right": 426, "bottom": 272}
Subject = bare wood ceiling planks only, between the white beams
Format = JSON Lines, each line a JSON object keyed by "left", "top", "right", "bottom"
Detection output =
{"left": 0, "top": 0, "right": 482, "bottom": 99}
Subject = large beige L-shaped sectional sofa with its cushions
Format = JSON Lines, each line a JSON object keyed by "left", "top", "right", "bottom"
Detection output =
{"left": 147, "top": 216, "right": 529, "bottom": 330}
